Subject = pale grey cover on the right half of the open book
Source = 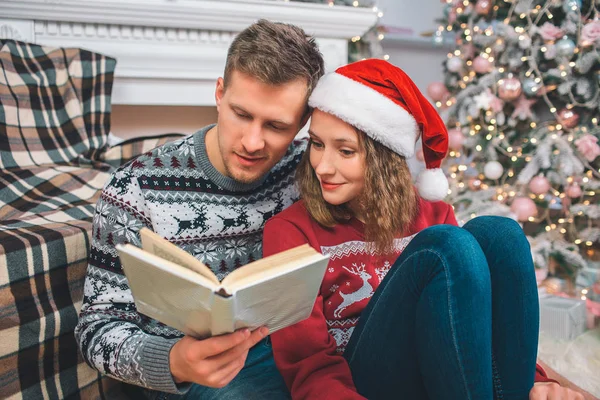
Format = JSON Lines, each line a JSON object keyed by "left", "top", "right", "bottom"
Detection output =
{"left": 234, "top": 253, "right": 329, "bottom": 333}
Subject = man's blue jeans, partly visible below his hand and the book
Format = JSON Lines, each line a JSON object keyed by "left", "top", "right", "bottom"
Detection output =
{"left": 146, "top": 336, "right": 291, "bottom": 400}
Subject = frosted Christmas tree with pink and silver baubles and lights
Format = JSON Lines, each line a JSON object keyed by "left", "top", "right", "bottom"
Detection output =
{"left": 427, "top": 0, "right": 600, "bottom": 297}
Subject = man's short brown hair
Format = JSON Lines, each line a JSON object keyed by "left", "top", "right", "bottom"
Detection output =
{"left": 224, "top": 19, "right": 324, "bottom": 98}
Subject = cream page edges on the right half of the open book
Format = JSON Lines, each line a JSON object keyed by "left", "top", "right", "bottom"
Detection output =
{"left": 221, "top": 244, "right": 323, "bottom": 294}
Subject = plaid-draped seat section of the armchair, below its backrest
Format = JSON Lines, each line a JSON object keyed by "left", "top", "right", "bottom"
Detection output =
{"left": 0, "top": 166, "right": 120, "bottom": 399}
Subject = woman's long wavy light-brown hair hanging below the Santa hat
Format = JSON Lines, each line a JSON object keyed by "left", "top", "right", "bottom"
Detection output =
{"left": 296, "top": 130, "right": 418, "bottom": 254}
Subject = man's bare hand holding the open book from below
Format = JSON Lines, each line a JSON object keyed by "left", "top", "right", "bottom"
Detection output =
{"left": 169, "top": 327, "right": 269, "bottom": 388}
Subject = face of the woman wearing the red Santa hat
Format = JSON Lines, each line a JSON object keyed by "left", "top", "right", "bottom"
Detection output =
{"left": 308, "top": 109, "right": 365, "bottom": 214}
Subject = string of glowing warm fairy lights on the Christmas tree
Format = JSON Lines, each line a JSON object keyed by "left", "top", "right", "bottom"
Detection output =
{"left": 433, "top": 0, "right": 600, "bottom": 262}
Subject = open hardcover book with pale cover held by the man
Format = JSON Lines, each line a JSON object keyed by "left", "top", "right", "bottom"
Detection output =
{"left": 117, "top": 228, "right": 329, "bottom": 338}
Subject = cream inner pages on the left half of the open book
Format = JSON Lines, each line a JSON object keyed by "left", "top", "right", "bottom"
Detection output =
{"left": 140, "top": 228, "right": 219, "bottom": 285}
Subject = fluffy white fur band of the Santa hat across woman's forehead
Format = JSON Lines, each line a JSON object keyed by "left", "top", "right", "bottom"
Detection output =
{"left": 308, "top": 72, "right": 419, "bottom": 157}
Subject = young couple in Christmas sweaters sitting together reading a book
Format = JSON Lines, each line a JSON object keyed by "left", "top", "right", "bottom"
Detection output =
{"left": 75, "top": 20, "right": 578, "bottom": 399}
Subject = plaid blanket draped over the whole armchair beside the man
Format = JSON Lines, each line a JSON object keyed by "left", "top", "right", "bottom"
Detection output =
{"left": 0, "top": 40, "right": 181, "bottom": 399}
